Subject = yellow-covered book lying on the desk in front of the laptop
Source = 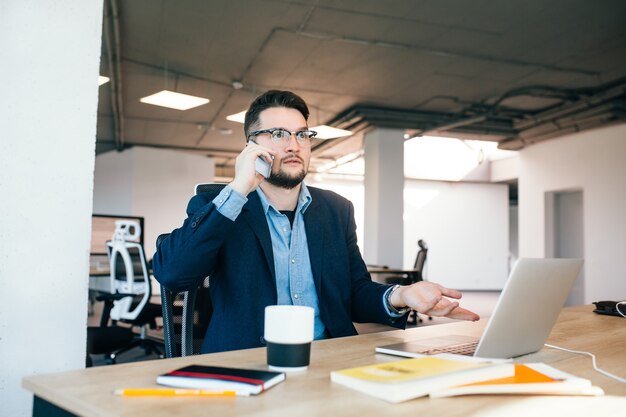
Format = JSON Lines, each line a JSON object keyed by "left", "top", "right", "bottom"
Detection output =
{"left": 330, "top": 356, "right": 514, "bottom": 403}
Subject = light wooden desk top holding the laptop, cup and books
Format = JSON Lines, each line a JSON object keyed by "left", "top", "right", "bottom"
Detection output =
{"left": 23, "top": 306, "right": 626, "bottom": 417}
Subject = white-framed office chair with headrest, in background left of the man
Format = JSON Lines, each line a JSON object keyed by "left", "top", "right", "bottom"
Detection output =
{"left": 101, "top": 220, "right": 163, "bottom": 361}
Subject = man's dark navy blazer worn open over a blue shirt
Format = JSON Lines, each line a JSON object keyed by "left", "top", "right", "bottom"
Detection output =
{"left": 153, "top": 187, "right": 406, "bottom": 353}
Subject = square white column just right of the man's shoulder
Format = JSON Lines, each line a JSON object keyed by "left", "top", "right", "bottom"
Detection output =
{"left": 363, "top": 129, "right": 404, "bottom": 268}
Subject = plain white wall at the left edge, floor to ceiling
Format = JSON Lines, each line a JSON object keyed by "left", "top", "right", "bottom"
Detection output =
{"left": 0, "top": 0, "right": 102, "bottom": 417}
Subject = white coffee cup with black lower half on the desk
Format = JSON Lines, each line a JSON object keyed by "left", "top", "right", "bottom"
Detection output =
{"left": 264, "top": 305, "right": 315, "bottom": 372}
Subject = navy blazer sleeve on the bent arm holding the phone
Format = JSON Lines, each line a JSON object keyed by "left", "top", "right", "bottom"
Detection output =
{"left": 152, "top": 193, "right": 235, "bottom": 292}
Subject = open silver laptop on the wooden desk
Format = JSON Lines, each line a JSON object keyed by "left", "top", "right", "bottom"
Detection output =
{"left": 376, "top": 258, "right": 583, "bottom": 359}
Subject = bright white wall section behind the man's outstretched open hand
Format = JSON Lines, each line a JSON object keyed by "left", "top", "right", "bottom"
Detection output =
{"left": 404, "top": 180, "right": 509, "bottom": 290}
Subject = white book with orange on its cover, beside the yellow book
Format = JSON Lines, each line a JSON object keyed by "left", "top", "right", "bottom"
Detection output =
{"left": 430, "top": 363, "right": 604, "bottom": 398}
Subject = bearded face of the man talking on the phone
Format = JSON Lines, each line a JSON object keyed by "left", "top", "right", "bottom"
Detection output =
{"left": 256, "top": 107, "right": 311, "bottom": 189}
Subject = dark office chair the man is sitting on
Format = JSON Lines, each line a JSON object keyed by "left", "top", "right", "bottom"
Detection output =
{"left": 156, "top": 183, "right": 226, "bottom": 358}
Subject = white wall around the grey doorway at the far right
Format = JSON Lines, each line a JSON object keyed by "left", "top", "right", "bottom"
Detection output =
{"left": 519, "top": 124, "right": 626, "bottom": 303}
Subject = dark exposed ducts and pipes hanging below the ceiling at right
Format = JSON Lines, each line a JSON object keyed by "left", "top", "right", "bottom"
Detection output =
{"left": 316, "top": 78, "right": 626, "bottom": 150}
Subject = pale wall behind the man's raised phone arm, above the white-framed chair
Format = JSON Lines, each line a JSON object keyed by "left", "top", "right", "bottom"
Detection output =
{"left": 93, "top": 146, "right": 215, "bottom": 258}
